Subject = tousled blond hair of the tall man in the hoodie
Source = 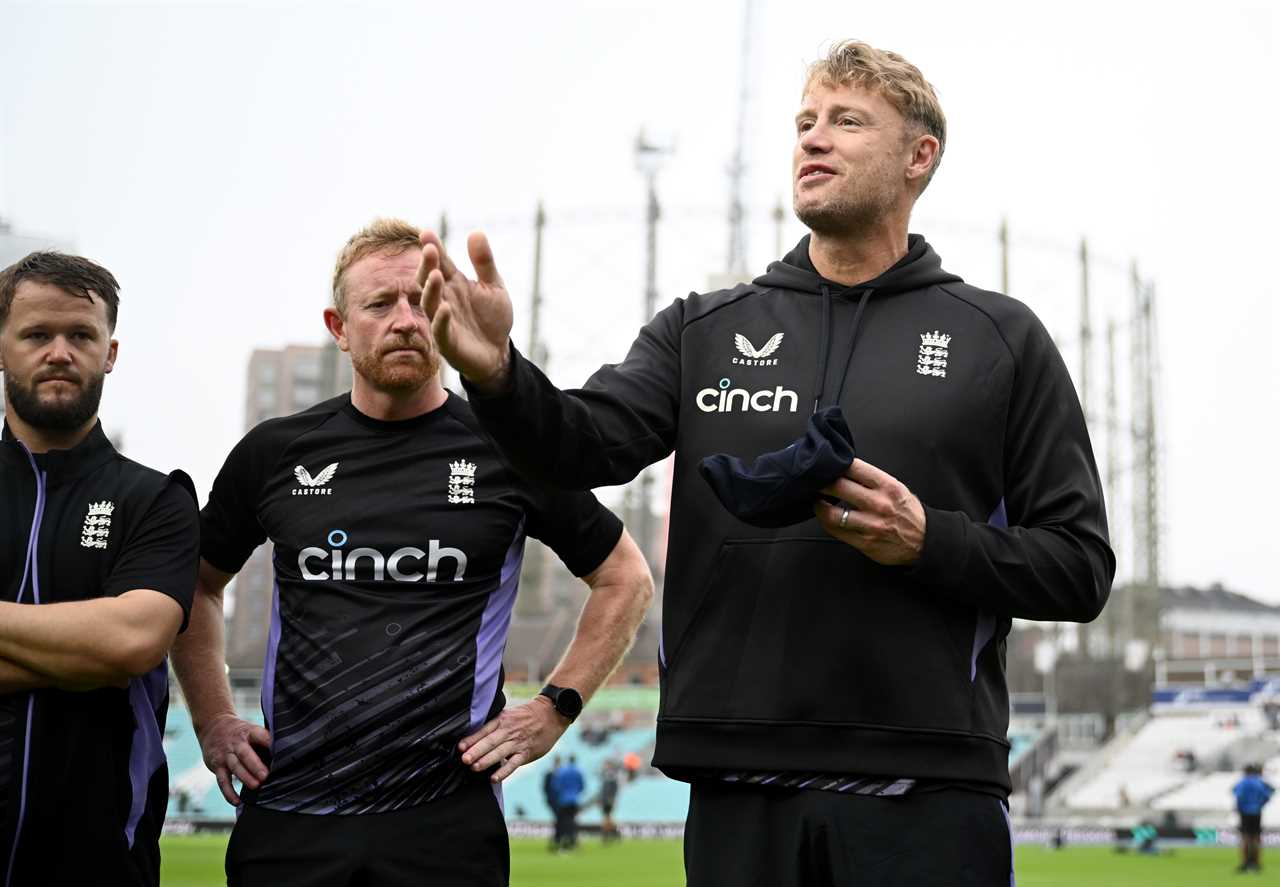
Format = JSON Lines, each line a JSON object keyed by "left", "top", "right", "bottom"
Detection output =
{"left": 804, "top": 40, "right": 947, "bottom": 191}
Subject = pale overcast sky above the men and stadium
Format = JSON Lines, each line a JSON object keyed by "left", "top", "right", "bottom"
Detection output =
{"left": 0, "top": 0, "right": 1280, "bottom": 603}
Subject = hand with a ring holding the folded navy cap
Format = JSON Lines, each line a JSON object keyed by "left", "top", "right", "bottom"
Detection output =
{"left": 813, "top": 459, "right": 924, "bottom": 567}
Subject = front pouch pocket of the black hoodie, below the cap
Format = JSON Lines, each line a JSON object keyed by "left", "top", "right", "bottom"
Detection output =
{"left": 664, "top": 539, "right": 973, "bottom": 730}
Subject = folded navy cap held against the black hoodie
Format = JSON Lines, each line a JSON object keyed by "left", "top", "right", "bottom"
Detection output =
{"left": 698, "top": 406, "right": 855, "bottom": 529}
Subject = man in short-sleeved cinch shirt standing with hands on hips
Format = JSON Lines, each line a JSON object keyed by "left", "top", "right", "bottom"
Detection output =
{"left": 174, "top": 219, "right": 653, "bottom": 887}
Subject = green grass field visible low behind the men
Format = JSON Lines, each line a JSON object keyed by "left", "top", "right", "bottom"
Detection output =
{"left": 160, "top": 836, "right": 1259, "bottom": 887}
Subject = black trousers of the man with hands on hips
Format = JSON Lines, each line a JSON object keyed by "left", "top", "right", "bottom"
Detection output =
{"left": 227, "top": 777, "right": 511, "bottom": 887}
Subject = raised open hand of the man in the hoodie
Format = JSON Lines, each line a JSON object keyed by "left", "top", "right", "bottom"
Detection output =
{"left": 417, "top": 230, "right": 511, "bottom": 392}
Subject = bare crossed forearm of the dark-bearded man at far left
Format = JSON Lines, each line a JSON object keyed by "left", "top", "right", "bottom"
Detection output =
{"left": 0, "top": 589, "right": 182, "bottom": 692}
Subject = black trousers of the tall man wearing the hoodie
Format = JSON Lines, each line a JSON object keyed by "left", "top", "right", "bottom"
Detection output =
{"left": 685, "top": 781, "right": 1014, "bottom": 887}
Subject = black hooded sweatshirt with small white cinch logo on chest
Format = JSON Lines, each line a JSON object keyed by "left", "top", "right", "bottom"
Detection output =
{"left": 472, "top": 236, "right": 1115, "bottom": 790}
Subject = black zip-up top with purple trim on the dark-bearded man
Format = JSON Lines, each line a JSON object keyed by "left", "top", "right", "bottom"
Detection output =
{"left": 0, "top": 425, "right": 200, "bottom": 887}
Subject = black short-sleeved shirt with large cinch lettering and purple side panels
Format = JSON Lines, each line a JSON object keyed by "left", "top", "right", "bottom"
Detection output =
{"left": 201, "top": 394, "right": 622, "bottom": 814}
